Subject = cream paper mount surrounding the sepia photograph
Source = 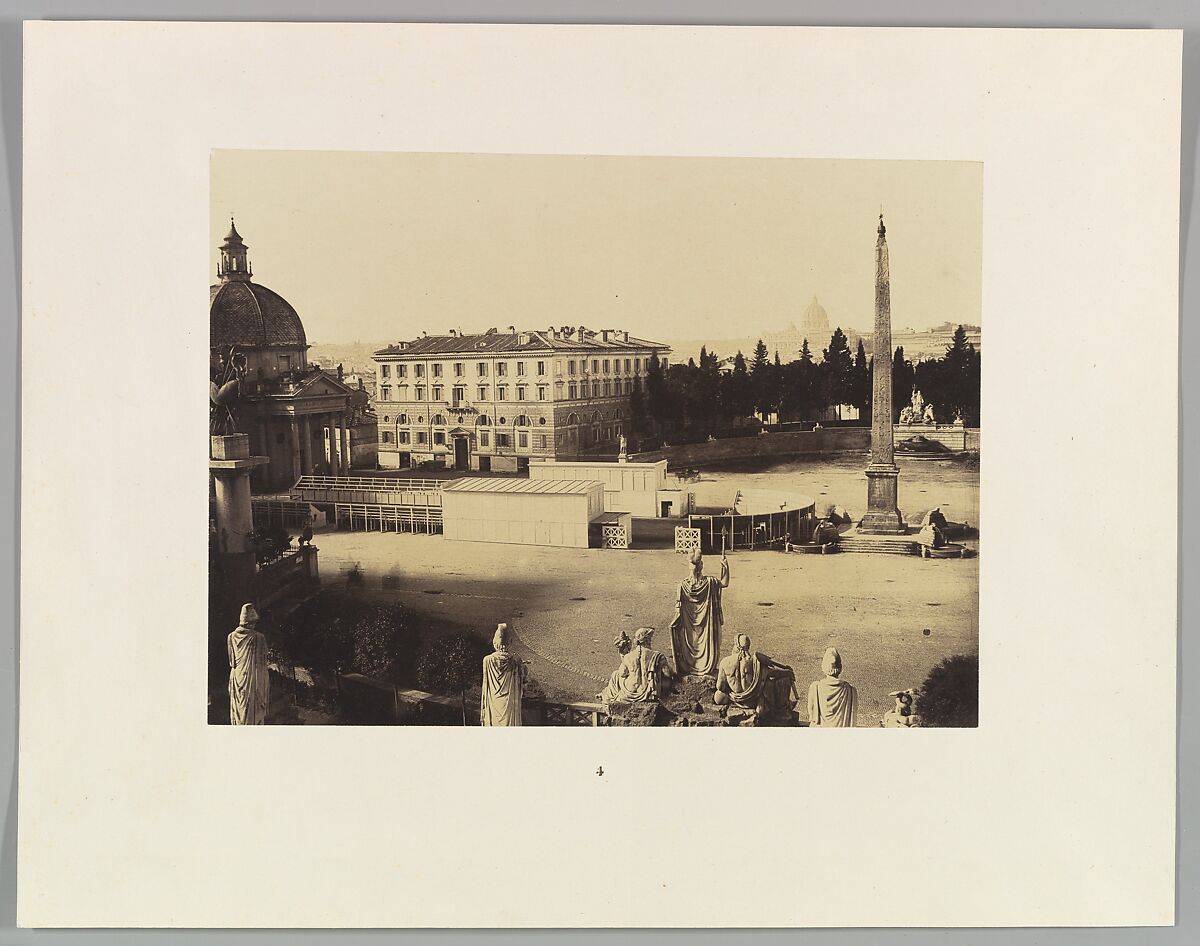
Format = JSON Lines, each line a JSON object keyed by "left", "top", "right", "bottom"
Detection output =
{"left": 18, "top": 23, "right": 1181, "bottom": 927}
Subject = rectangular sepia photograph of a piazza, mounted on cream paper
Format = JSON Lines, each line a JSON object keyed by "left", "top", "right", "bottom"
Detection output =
{"left": 208, "top": 151, "right": 979, "bottom": 729}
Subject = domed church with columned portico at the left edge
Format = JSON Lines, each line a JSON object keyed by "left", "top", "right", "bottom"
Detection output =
{"left": 209, "top": 220, "right": 374, "bottom": 492}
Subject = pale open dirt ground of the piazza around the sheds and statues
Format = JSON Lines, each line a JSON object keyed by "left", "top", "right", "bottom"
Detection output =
{"left": 304, "top": 459, "right": 979, "bottom": 725}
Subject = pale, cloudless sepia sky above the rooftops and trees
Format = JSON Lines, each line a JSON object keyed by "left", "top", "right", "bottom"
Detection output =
{"left": 209, "top": 151, "right": 983, "bottom": 343}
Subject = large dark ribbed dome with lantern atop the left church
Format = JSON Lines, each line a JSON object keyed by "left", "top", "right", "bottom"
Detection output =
{"left": 209, "top": 218, "right": 307, "bottom": 348}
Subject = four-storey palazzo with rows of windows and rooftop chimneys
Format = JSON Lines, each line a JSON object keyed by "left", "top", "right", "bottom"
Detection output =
{"left": 374, "top": 325, "right": 671, "bottom": 471}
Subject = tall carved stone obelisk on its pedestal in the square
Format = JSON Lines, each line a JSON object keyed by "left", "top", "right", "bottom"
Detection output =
{"left": 858, "top": 214, "right": 906, "bottom": 535}
